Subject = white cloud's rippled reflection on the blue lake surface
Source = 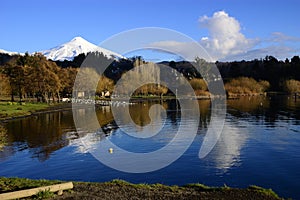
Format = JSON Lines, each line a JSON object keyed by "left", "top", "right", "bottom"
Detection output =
{"left": 208, "top": 119, "right": 248, "bottom": 173}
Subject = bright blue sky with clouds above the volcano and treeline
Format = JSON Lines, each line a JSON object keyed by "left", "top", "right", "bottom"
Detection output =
{"left": 0, "top": 0, "right": 300, "bottom": 60}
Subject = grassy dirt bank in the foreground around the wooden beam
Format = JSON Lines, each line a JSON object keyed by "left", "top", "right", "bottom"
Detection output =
{"left": 0, "top": 177, "right": 280, "bottom": 200}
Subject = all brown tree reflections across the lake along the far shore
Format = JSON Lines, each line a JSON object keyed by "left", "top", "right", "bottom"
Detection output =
{"left": 0, "top": 96, "right": 300, "bottom": 161}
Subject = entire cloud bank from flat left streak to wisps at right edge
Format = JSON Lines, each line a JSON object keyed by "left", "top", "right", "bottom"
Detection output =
{"left": 151, "top": 11, "right": 300, "bottom": 61}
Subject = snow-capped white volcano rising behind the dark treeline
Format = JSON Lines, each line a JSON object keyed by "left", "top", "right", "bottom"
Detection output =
{"left": 41, "top": 37, "right": 123, "bottom": 61}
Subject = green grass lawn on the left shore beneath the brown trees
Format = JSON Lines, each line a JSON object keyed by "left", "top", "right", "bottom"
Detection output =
{"left": 0, "top": 102, "right": 50, "bottom": 119}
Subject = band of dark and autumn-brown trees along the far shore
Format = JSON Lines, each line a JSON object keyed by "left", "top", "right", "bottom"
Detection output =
{"left": 0, "top": 52, "right": 300, "bottom": 102}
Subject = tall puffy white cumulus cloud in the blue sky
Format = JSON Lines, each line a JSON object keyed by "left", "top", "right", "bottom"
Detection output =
{"left": 199, "top": 11, "right": 258, "bottom": 60}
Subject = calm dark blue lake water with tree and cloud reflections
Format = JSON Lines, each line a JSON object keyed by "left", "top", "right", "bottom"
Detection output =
{"left": 0, "top": 96, "right": 300, "bottom": 199}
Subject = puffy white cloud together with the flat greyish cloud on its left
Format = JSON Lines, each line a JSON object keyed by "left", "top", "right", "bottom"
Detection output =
{"left": 151, "top": 11, "right": 258, "bottom": 61}
